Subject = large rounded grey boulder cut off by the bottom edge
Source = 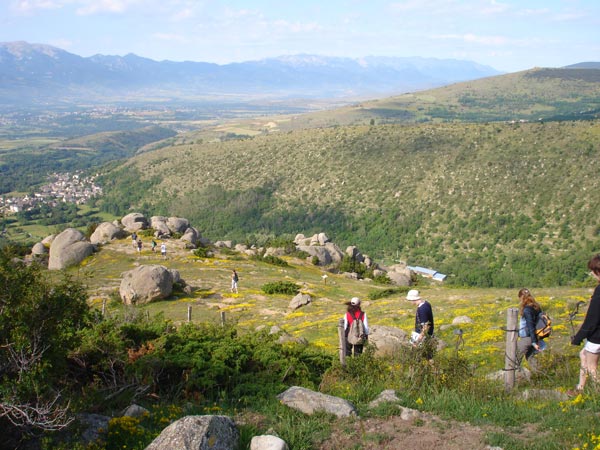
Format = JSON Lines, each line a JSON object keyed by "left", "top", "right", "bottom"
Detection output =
{"left": 146, "top": 416, "right": 240, "bottom": 450}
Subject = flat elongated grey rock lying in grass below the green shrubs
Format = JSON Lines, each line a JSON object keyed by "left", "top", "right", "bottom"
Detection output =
{"left": 277, "top": 386, "right": 356, "bottom": 417}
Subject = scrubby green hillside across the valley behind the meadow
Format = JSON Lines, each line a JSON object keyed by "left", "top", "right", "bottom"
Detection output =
{"left": 96, "top": 121, "right": 600, "bottom": 287}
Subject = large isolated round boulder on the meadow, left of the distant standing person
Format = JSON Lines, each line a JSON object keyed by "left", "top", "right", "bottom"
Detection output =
{"left": 119, "top": 265, "right": 174, "bottom": 305}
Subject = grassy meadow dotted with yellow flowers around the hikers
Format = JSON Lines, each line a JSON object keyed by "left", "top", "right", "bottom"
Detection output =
{"left": 62, "top": 238, "right": 600, "bottom": 450}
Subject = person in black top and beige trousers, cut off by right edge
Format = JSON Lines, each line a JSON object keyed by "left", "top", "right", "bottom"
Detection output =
{"left": 567, "top": 254, "right": 600, "bottom": 396}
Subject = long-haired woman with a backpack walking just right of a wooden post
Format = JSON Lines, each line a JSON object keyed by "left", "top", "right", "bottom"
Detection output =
{"left": 517, "top": 288, "right": 546, "bottom": 372}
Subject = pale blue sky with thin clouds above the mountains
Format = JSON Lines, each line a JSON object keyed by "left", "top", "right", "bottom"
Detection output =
{"left": 0, "top": 0, "right": 600, "bottom": 72}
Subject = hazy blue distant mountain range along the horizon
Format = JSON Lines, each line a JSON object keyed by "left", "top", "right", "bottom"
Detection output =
{"left": 0, "top": 42, "right": 500, "bottom": 106}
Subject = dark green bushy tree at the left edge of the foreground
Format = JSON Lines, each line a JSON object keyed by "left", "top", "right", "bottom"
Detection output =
{"left": 0, "top": 250, "right": 89, "bottom": 437}
